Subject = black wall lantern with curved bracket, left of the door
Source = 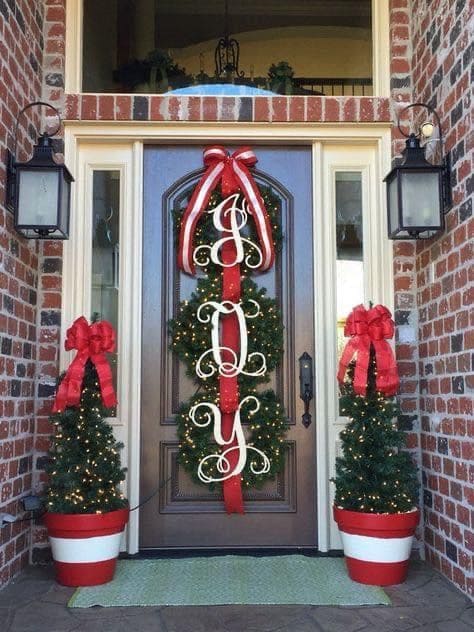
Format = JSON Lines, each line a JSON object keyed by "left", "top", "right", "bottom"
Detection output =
{"left": 6, "top": 101, "right": 74, "bottom": 239}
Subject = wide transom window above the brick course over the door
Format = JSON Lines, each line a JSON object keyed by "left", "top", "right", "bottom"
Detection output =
{"left": 82, "top": 0, "right": 373, "bottom": 96}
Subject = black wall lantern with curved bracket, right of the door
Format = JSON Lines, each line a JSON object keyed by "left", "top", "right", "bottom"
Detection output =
{"left": 384, "top": 103, "right": 452, "bottom": 239}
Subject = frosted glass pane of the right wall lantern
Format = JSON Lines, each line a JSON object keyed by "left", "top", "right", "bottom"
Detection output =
{"left": 401, "top": 171, "right": 441, "bottom": 228}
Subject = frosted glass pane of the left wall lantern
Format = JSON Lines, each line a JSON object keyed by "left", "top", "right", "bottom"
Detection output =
{"left": 17, "top": 169, "right": 59, "bottom": 227}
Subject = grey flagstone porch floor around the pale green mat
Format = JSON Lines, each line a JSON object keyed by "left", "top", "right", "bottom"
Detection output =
{"left": 0, "top": 562, "right": 474, "bottom": 632}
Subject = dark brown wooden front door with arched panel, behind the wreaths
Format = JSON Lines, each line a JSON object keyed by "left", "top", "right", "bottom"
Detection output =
{"left": 140, "top": 146, "right": 316, "bottom": 549}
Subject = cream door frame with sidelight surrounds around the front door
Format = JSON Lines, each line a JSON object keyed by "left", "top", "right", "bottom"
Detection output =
{"left": 60, "top": 121, "right": 393, "bottom": 554}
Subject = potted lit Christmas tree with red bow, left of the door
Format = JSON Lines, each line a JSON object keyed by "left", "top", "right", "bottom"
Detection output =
{"left": 44, "top": 317, "right": 129, "bottom": 586}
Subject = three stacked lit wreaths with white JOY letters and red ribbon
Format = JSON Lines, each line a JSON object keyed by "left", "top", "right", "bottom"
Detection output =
{"left": 169, "top": 146, "right": 287, "bottom": 513}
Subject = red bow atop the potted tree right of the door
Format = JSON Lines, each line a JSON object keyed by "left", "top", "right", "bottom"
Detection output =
{"left": 337, "top": 305, "right": 400, "bottom": 397}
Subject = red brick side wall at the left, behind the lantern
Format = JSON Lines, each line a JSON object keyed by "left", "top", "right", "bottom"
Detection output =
{"left": 0, "top": 0, "right": 43, "bottom": 586}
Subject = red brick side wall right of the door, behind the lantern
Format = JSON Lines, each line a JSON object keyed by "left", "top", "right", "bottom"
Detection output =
{"left": 412, "top": 0, "right": 474, "bottom": 595}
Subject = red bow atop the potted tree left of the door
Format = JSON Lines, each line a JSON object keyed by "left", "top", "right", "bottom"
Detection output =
{"left": 53, "top": 316, "right": 117, "bottom": 413}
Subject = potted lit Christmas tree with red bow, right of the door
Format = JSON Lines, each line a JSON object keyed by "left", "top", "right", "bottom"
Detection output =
{"left": 333, "top": 305, "right": 420, "bottom": 586}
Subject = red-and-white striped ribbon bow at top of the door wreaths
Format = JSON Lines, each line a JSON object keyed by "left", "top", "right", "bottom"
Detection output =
{"left": 178, "top": 145, "right": 275, "bottom": 274}
